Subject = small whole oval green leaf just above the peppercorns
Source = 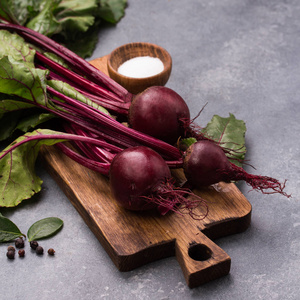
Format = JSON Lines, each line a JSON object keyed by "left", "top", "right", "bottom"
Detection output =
{"left": 27, "top": 217, "right": 63, "bottom": 242}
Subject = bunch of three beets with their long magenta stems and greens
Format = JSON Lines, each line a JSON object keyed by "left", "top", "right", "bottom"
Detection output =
{"left": 0, "top": 23, "right": 289, "bottom": 217}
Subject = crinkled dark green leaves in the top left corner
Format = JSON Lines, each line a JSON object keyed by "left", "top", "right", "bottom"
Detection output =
{"left": 0, "top": 0, "right": 127, "bottom": 58}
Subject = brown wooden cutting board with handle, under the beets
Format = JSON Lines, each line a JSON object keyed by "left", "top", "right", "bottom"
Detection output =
{"left": 41, "top": 56, "right": 251, "bottom": 288}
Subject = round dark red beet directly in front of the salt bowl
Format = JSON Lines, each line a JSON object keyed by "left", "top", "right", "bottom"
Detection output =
{"left": 128, "top": 86, "right": 190, "bottom": 144}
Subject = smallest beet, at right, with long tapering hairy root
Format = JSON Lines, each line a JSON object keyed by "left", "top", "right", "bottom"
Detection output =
{"left": 184, "top": 140, "right": 289, "bottom": 197}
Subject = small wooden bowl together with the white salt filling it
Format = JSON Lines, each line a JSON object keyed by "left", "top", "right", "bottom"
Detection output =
{"left": 107, "top": 43, "right": 172, "bottom": 94}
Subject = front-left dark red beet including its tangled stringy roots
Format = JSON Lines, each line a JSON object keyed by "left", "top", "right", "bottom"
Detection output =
{"left": 109, "top": 146, "right": 207, "bottom": 218}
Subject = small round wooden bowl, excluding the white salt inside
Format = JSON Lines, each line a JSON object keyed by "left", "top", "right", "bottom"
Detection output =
{"left": 107, "top": 43, "right": 172, "bottom": 95}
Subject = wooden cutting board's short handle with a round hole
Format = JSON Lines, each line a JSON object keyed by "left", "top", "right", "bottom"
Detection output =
{"left": 175, "top": 232, "right": 231, "bottom": 288}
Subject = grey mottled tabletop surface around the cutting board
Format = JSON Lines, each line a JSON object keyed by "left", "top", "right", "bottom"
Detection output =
{"left": 0, "top": 0, "right": 300, "bottom": 300}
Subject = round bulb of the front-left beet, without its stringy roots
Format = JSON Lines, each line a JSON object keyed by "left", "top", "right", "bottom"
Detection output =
{"left": 109, "top": 147, "right": 171, "bottom": 210}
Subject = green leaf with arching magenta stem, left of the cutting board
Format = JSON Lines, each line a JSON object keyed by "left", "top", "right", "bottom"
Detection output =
{"left": 0, "top": 129, "right": 66, "bottom": 207}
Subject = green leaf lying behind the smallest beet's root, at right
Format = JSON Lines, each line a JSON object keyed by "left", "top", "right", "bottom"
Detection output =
{"left": 202, "top": 114, "right": 246, "bottom": 166}
